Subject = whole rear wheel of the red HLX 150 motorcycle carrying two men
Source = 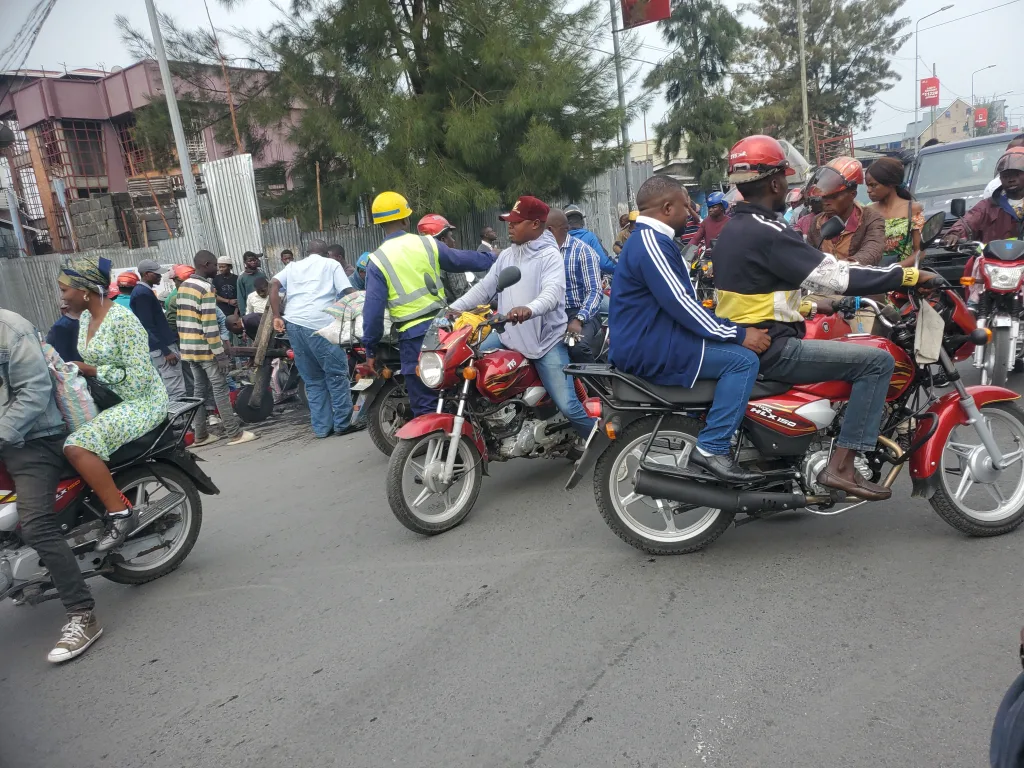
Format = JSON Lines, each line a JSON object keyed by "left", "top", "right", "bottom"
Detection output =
{"left": 594, "top": 416, "right": 735, "bottom": 555}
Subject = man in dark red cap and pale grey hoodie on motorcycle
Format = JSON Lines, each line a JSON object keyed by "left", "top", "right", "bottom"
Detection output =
{"left": 452, "top": 196, "right": 594, "bottom": 438}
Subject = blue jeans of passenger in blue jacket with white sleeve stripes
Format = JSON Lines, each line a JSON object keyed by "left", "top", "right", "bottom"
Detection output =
{"left": 697, "top": 341, "right": 758, "bottom": 456}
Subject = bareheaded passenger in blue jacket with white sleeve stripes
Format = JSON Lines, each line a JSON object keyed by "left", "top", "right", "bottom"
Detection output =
{"left": 608, "top": 176, "right": 769, "bottom": 482}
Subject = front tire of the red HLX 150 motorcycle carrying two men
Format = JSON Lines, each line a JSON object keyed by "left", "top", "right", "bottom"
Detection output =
{"left": 929, "top": 402, "right": 1024, "bottom": 537}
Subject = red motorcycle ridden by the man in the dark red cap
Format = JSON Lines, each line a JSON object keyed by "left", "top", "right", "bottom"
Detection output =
{"left": 387, "top": 267, "right": 586, "bottom": 536}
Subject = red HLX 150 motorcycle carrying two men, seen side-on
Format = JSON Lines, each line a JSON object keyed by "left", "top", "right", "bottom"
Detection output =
{"left": 566, "top": 282, "right": 1024, "bottom": 555}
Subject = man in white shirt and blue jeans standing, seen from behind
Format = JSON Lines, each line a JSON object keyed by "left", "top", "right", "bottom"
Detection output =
{"left": 270, "top": 240, "right": 364, "bottom": 438}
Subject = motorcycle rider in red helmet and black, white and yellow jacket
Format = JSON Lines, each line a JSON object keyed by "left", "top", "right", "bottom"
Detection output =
{"left": 712, "top": 135, "right": 934, "bottom": 501}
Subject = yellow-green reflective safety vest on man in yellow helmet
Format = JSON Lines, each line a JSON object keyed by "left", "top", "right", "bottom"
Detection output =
{"left": 370, "top": 233, "right": 444, "bottom": 333}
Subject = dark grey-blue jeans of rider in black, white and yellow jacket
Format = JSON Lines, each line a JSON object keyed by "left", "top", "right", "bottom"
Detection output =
{"left": 761, "top": 339, "right": 896, "bottom": 451}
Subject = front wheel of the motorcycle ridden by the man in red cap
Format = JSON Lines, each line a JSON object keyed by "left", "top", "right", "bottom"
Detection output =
{"left": 387, "top": 432, "right": 483, "bottom": 536}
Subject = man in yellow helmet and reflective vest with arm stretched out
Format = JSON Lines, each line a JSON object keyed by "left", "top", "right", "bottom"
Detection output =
{"left": 362, "top": 191, "right": 495, "bottom": 416}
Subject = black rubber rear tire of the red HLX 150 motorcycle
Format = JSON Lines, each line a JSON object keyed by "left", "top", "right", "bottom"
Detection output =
{"left": 594, "top": 416, "right": 735, "bottom": 555}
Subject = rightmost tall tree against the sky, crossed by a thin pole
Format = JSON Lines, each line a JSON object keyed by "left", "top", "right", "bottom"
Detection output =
{"left": 734, "top": 0, "right": 910, "bottom": 141}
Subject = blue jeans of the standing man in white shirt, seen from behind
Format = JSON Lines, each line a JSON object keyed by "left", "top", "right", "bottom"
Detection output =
{"left": 286, "top": 323, "right": 352, "bottom": 437}
